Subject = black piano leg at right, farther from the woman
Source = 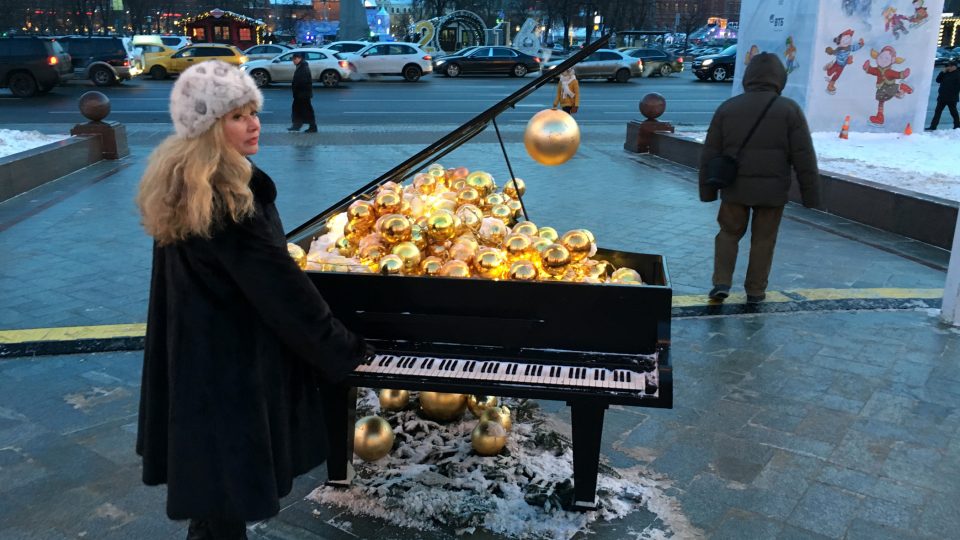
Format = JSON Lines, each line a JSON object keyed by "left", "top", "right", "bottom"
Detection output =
{"left": 570, "top": 402, "right": 607, "bottom": 511}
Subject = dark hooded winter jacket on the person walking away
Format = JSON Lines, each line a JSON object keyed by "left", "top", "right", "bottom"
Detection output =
{"left": 700, "top": 53, "right": 820, "bottom": 207}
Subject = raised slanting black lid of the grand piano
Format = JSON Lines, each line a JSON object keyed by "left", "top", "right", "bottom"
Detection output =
{"left": 287, "top": 33, "right": 613, "bottom": 243}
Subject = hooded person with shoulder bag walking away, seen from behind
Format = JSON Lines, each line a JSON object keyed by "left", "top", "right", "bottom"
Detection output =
{"left": 700, "top": 53, "right": 820, "bottom": 302}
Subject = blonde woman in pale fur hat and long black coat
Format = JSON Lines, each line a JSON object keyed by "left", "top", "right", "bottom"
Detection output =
{"left": 131, "top": 61, "right": 366, "bottom": 539}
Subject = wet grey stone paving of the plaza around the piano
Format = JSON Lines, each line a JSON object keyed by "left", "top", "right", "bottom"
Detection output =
{"left": 0, "top": 126, "right": 960, "bottom": 540}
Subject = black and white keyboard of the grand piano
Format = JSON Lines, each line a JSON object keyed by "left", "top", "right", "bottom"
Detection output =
{"left": 354, "top": 354, "right": 657, "bottom": 393}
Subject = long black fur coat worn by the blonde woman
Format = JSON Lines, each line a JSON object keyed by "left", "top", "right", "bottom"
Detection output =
{"left": 137, "top": 168, "right": 365, "bottom": 521}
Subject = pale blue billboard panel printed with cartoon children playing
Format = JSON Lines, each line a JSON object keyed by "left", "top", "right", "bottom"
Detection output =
{"left": 733, "top": 0, "right": 943, "bottom": 132}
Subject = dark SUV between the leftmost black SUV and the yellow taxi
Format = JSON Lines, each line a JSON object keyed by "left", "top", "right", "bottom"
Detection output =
{"left": 57, "top": 36, "right": 143, "bottom": 86}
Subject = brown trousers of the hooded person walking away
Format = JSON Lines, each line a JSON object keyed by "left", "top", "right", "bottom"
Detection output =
{"left": 713, "top": 202, "right": 783, "bottom": 296}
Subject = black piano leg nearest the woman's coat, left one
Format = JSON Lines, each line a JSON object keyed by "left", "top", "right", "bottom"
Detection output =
{"left": 323, "top": 385, "right": 357, "bottom": 487}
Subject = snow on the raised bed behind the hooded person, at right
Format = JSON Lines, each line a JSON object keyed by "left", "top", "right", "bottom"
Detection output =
{"left": 677, "top": 129, "right": 960, "bottom": 201}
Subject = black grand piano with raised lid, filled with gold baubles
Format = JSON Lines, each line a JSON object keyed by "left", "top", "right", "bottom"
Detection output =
{"left": 287, "top": 39, "right": 673, "bottom": 510}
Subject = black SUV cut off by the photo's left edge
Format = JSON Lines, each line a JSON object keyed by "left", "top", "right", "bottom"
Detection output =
{"left": 0, "top": 36, "right": 73, "bottom": 97}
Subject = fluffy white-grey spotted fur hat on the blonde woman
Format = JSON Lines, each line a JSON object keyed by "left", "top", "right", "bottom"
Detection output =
{"left": 170, "top": 60, "right": 263, "bottom": 138}
